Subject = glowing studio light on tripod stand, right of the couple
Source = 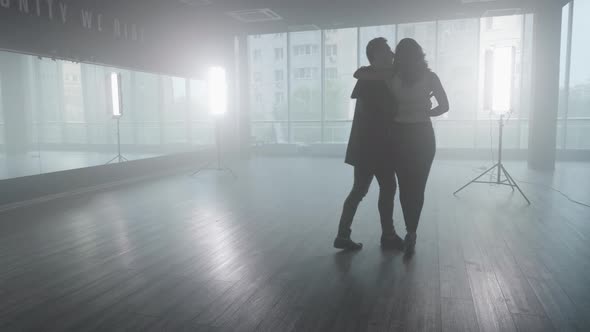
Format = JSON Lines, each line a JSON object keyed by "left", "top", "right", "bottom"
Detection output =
{"left": 453, "top": 47, "right": 531, "bottom": 205}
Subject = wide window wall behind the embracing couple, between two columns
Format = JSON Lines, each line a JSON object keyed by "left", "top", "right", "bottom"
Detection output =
{"left": 249, "top": 15, "right": 544, "bottom": 151}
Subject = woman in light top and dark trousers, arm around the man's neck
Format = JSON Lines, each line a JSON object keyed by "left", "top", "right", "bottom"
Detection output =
{"left": 354, "top": 38, "right": 449, "bottom": 253}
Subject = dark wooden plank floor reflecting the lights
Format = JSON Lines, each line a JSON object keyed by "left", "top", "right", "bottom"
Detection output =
{"left": 0, "top": 159, "right": 590, "bottom": 332}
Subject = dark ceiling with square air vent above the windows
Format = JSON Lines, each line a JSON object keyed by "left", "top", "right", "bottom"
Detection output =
{"left": 146, "top": 0, "right": 566, "bottom": 35}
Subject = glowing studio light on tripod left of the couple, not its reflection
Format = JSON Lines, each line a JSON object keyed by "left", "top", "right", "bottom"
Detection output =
{"left": 192, "top": 67, "right": 236, "bottom": 178}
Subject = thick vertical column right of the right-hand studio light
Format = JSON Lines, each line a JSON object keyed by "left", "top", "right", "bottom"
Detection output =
{"left": 528, "top": 1, "right": 561, "bottom": 170}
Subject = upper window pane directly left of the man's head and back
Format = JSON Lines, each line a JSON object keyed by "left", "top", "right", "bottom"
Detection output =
{"left": 324, "top": 28, "right": 357, "bottom": 120}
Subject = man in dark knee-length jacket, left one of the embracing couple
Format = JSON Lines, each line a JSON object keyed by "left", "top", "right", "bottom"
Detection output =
{"left": 334, "top": 38, "right": 403, "bottom": 250}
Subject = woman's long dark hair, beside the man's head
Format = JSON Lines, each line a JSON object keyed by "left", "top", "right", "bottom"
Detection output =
{"left": 393, "top": 38, "right": 430, "bottom": 85}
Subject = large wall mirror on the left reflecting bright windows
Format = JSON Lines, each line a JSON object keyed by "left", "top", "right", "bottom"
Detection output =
{"left": 0, "top": 52, "right": 214, "bottom": 179}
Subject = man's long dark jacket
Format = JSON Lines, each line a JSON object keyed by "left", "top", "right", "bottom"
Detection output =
{"left": 344, "top": 80, "right": 396, "bottom": 173}
